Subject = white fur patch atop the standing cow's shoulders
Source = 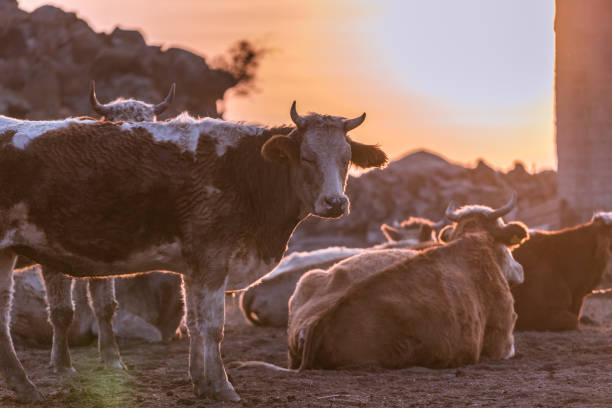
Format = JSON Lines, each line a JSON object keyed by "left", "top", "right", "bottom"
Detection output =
{"left": 121, "top": 113, "right": 264, "bottom": 156}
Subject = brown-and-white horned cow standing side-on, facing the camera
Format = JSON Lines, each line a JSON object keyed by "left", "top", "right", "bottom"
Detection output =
{"left": 0, "top": 102, "right": 387, "bottom": 401}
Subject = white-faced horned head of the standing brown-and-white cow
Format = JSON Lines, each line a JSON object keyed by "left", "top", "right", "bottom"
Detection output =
{"left": 261, "top": 101, "right": 388, "bottom": 218}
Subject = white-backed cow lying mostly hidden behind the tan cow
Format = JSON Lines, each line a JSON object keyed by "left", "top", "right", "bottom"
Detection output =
{"left": 240, "top": 218, "right": 445, "bottom": 327}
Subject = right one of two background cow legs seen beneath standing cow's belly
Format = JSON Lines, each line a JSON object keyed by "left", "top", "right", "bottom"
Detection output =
{"left": 89, "top": 278, "right": 125, "bottom": 369}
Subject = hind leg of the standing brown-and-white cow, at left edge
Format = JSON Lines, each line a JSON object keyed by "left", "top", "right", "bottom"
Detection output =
{"left": 0, "top": 249, "right": 42, "bottom": 403}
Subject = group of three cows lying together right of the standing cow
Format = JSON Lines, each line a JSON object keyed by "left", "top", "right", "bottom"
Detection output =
{"left": 234, "top": 197, "right": 612, "bottom": 369}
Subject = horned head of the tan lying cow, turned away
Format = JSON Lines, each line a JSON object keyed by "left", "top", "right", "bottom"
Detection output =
{"left": 438, "top": 194, "right": 529, "bottom": 283}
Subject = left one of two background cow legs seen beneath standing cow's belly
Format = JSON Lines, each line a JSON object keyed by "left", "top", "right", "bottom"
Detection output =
{"left": 42, "top": 265, "right": 75, "bottom": 373}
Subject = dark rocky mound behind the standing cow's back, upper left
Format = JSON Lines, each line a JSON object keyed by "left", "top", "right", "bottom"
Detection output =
{"left": 0, "top": 0, "right": 258, "bottom": 119}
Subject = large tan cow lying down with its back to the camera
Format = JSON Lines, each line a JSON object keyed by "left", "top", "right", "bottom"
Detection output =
{"left": 288, "top": 196, "right": 528, "bottom": 370}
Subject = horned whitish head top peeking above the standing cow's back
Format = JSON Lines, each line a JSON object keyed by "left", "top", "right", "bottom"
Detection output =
{"left": 89, "top": 81, "right": 176, "bottom": 122}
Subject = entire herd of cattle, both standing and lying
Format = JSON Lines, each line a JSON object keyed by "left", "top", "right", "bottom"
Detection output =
{"left": 0, "top": 82, "right": 612, "bottom": 402}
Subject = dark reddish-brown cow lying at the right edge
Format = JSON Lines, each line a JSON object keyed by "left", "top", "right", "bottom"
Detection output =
{"left": 512, "top": 213, "right": 612, "bottom": 331}
